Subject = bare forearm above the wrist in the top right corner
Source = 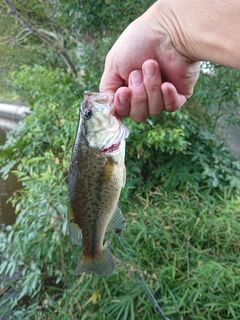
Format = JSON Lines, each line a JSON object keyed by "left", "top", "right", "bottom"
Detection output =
{"left": 153, "top": 0, "right": 240, "bottom": 69}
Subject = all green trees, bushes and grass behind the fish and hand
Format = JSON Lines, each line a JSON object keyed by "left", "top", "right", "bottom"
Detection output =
{"left": 0, "top": 0, "right": 240, "bottom": 320}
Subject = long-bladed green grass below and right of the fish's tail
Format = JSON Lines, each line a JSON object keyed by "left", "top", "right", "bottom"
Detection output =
{"left": 8, "top": 187, "right": 240, "bottom": 320}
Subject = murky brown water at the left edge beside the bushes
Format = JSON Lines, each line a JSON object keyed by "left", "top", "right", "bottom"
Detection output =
{"left": 0, "top": 124, "right": 20, "bottom": 227}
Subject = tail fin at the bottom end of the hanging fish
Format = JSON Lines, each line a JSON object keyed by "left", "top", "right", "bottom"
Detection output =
{"left": 74, "top": 248, "right": 115, "bottom": 276}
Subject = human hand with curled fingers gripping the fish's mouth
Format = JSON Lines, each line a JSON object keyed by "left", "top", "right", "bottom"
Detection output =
{"left": 100, "top": 1, "right": 200, "bottom": 122}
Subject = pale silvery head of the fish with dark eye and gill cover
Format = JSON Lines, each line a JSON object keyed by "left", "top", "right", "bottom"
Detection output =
{"left": 81, "top": 92, "right": 129, "bottom": 153}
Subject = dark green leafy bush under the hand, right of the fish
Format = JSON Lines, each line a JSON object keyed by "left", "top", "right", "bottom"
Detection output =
{"left": 122, "top": 107, "right": 240, "bottom": 196}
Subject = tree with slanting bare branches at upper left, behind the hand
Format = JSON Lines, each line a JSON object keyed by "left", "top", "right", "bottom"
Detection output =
{"left": 0, "top": 0, "right": 153, "bottom": 96}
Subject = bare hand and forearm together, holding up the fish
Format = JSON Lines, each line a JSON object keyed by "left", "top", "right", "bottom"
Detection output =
{"left": 100, "top": 0, "right": 240, "bottom": 122}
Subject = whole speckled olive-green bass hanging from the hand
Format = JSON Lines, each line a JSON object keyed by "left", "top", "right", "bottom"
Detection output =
{"left": 68, "top": 91, "right": 130, "bottom": 276}
